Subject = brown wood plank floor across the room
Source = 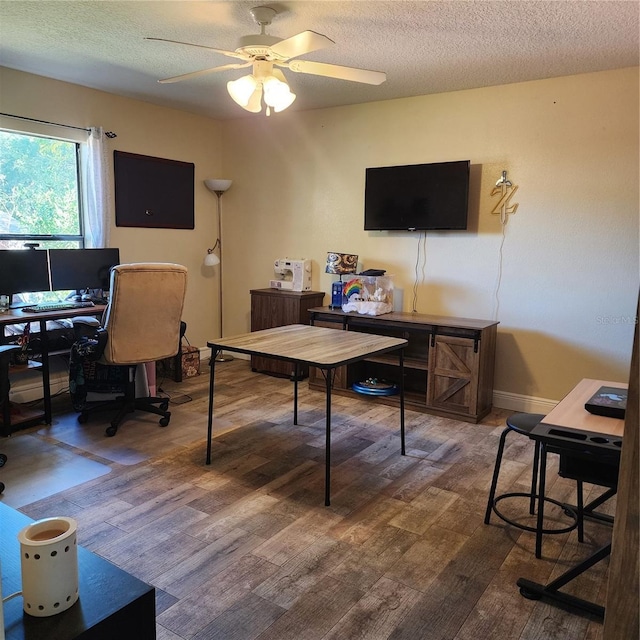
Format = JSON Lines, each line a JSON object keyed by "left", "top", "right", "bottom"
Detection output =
{"left": 0, "top": 359, "right": 614, "bottom": 640}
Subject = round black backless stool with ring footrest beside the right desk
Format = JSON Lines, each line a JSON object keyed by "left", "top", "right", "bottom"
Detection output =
{"left": 484, "top": 413, "right": 582, "bottom": 558}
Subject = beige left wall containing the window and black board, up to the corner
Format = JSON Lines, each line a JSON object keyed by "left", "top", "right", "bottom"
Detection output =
{"left": 0, "top": 67, "right": 222, "bottom": 345}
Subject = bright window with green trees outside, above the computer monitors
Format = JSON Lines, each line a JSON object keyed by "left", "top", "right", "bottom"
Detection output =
{"left": 0, "top": 130, "right": 84, "bottom": 249}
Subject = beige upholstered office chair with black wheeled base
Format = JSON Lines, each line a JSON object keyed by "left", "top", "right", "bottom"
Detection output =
{"left": 70, "top": 263, "right": 187, "bottom": 436}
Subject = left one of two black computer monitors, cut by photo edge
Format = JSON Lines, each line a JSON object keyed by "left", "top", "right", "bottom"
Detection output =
{"left": 0, "top": 249, "right": 49, "bottom": 296}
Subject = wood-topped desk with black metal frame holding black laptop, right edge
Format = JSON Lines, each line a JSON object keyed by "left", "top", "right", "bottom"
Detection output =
{"left": 517, "top": 378, "right": 627, "bottom": 618}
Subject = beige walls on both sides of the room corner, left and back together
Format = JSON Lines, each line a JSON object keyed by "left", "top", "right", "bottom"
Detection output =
{"left": 0, "top": 68, "right": 639, "bottom": 408}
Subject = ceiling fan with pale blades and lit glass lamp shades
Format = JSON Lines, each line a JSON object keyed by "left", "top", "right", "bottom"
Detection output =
{"left": 145, "top": 7, "right": 387, "bottom": 115}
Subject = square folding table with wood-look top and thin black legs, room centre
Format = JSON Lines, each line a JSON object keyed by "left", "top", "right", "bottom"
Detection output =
{"left": 206, "top": 324, "right": 407, "bottom": 506}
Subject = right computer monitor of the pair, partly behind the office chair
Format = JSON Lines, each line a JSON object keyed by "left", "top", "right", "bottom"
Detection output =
{"left": 49, "top": 249, "right": 120, "bottom": 291}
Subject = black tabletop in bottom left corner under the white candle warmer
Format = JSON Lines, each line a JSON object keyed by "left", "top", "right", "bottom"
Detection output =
{"left": 0, "top": 502, "right": 156, "bottom": 640}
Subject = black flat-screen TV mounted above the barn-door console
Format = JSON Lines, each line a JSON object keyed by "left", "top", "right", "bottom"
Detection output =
{"left": 364, "top": 160, "right": 471, "bottom": 231}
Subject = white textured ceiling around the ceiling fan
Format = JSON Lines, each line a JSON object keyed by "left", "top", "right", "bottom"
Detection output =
{"left": 0, "top": 0, "right": 640, "bottom": 119}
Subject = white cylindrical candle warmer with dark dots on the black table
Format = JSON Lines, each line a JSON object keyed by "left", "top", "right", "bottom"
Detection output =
{"left": 18, "top": 517, "right": 78, "bottom": 617}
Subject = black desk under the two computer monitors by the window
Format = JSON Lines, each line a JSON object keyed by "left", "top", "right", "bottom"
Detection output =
{"left": 0, "top": 305, "right": 106, "bottom": 435}
